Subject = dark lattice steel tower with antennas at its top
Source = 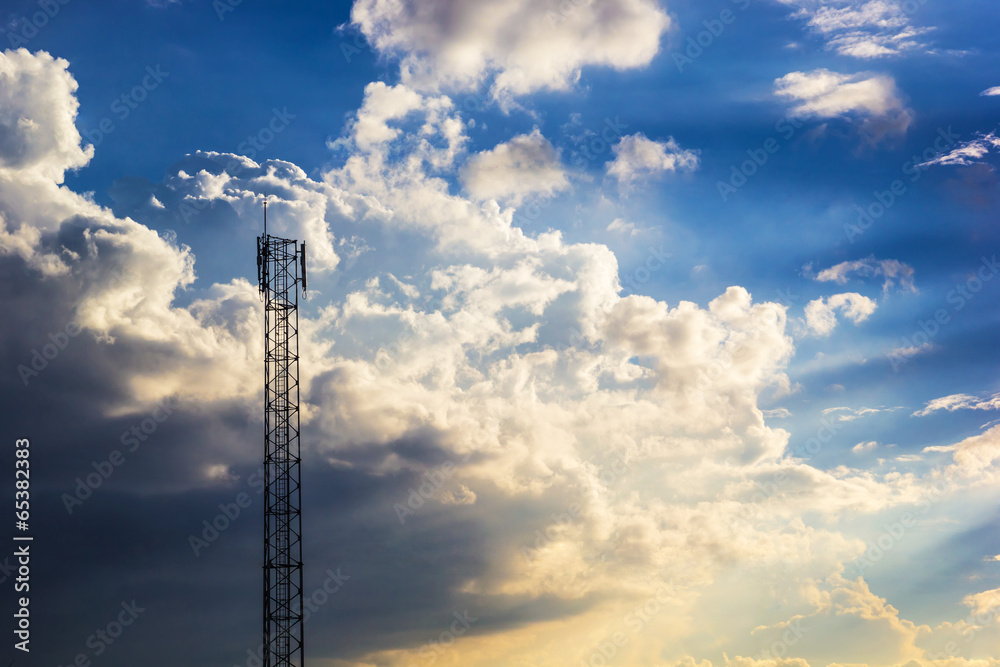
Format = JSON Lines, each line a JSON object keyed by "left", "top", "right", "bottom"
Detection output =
{"left": 257, "top": 200, "right": 306, "bottom": 667}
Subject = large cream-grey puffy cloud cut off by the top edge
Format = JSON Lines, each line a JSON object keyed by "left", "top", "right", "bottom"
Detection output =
{"left": 351, "top": 0, "right": 671, "bottom": 100}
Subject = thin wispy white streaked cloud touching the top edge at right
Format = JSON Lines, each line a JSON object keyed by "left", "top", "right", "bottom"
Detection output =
{"left": 778, "top": 0, "right": 932, "bottom": 59}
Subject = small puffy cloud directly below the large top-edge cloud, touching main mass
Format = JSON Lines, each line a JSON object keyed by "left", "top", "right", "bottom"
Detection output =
{"left": 460, "top": 128, "right": 569, "bottom": 205}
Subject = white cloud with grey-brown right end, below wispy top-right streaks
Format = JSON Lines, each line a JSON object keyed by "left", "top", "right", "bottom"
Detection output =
{"left": 774, "top": 69, "right": 913, "bottom": 142}
